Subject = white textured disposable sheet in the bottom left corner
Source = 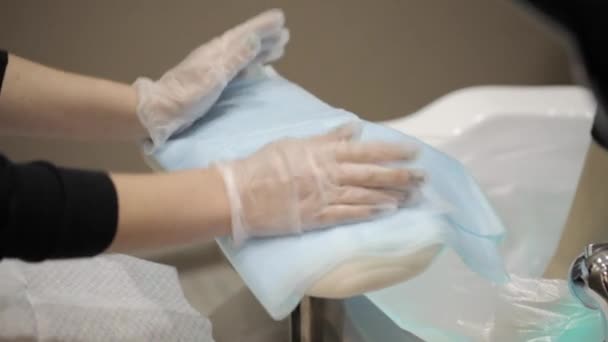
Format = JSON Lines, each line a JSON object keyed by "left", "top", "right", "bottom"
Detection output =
{"left": 0, "top": 254, "right": 213, "bottom": 342}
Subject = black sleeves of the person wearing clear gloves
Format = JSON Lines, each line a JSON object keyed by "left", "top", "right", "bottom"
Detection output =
{"left": 0, "top": 51, "right": 118, "bottom": 261}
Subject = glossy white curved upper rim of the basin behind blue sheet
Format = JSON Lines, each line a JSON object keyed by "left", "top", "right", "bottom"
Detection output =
{"left": 380, "top": 86, "right": 595, "bottom": 145}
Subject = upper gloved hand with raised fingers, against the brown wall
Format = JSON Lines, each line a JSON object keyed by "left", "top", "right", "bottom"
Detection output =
{"left": 133, "top": 10, "right": 289, "bottom": 151}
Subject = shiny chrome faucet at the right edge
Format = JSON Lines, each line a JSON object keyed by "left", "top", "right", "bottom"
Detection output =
{"left": 568, "top": 243, "right": 608, "bottom": 338}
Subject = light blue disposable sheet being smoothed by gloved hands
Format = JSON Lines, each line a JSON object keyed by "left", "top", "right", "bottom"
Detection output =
{"left": 149, "top": 65, "right": 506, "bottom": 319}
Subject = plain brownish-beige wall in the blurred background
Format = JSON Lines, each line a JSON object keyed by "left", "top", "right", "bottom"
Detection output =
{"left": 0, "top": 0, "right": 570, "bottom": 171}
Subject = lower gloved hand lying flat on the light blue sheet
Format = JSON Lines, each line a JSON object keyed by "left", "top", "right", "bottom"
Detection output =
{"left": 218, "top": 124, "right": 424, "bottom": 244}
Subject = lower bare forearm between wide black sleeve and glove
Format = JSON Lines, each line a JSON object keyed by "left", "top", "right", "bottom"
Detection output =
{"left": 110, "top": 169, "right": 230, "bottom": 252}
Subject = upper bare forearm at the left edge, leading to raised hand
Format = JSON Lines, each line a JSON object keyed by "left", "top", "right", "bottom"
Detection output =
{"left": 0, "top": 55, "right": 146, "bottom": 140}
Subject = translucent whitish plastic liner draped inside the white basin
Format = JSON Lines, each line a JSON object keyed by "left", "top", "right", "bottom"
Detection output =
{"left": 367, "top": 93, "right": 598, "bottom": 341}
